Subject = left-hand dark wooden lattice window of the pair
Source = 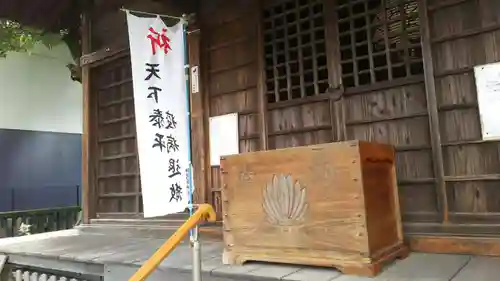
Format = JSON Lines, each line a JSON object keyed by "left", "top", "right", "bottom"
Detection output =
{"left": 263, "top": 0, "right": 328, "bottom": 103}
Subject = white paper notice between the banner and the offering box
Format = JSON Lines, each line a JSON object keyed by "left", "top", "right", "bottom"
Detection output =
{"left": 209, "top": 113, "right": 240, "bottom": 166}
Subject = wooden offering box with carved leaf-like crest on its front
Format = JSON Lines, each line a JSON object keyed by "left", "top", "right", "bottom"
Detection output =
{"left": 221, "top": 141, "right": 408, "bottom": 276}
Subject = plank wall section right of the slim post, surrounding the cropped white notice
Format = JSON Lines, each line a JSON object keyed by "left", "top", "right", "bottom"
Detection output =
{"left": 429, "top": 0, "right": 500, "bottom": 235}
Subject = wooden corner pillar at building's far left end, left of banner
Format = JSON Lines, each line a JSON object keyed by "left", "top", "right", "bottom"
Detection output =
{"left": 80, "top": 9, "right": 95, "bottom": 223}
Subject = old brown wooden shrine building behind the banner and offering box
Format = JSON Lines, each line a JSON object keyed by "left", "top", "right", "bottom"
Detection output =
{"left": 0, "top": 0, "right": 500, "bottom": 255}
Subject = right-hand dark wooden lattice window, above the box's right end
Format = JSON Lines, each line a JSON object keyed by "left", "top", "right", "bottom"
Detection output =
{"left": 337, "top": 0, "right": 423, "bottom": 87}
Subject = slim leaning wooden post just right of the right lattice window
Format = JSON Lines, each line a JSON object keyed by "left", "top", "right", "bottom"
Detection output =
{"left": 418, "top": 0, "right": 449, "bottom": 223}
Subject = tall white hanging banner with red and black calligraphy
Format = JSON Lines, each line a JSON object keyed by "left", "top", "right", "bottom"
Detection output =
{"left": 127, "top": 12, "right": 190, "bottom": 218}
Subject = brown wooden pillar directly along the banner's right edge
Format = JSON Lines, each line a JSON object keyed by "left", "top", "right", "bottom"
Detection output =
{"left": 187, "top": 21, "right": 210, "bottom": 204}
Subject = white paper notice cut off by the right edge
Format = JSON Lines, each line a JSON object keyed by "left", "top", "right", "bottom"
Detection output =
{"left": 474, "top": 62, "right": 500, "bottom": 140}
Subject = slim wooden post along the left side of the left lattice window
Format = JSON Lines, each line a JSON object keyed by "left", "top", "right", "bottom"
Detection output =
{"left": 255, "top": 0, "right": 269, "bottom": 150}
